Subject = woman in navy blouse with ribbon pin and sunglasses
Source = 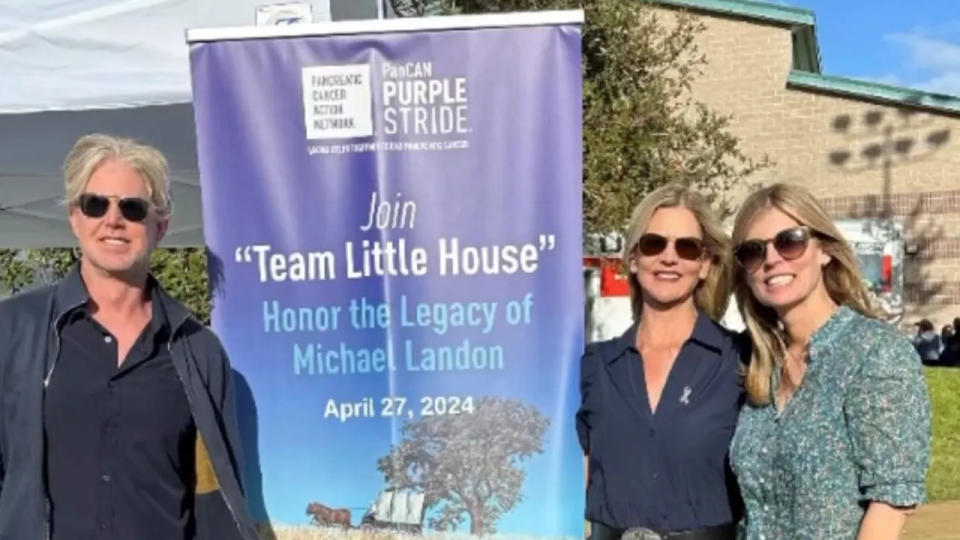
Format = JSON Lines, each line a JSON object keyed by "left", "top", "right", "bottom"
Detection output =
{"left": 577, "top": 185, "right": 742, "bottom": 540}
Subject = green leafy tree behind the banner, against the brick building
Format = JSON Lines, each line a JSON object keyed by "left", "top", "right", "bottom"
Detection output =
{"left": 432, "top": 0, "right": 770, "bottom": 234}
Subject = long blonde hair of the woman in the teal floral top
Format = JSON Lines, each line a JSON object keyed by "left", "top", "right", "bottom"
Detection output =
{"left": 733, "top": 183, "right": 876, "bottom": 405}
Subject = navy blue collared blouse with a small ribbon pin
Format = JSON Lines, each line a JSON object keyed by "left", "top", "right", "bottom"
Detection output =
{"left": 577, "top": 313, "right": 749, "bottom": 531}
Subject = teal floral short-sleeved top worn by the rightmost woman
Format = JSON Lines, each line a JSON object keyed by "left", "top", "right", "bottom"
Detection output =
{"left": 730, "top": 307, "right": 930, "bottom": 540}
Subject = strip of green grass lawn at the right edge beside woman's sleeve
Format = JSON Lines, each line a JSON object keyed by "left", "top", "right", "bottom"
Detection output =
{"left": 926, "top": 367, "right": 960, "bottom": 502}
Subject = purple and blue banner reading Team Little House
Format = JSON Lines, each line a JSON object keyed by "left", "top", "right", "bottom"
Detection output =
{"left": 185, "top": 12, "right": 584, "bottom": 539}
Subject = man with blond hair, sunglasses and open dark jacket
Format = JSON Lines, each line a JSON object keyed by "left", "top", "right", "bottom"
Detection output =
{"left": 0, "top": 135, "right": 256, "bottom": 540}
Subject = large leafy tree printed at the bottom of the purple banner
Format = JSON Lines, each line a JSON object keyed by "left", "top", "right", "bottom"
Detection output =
{"left": 377, "top": 397, "right": 550, "bottom": 534}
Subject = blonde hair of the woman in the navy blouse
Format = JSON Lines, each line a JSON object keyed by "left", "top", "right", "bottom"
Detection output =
{"left": 621, "top": 183, "right": 730, "bottom": 321}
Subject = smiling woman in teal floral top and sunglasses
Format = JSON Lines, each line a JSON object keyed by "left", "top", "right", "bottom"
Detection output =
{"left": 730, "top": 184, "right": 930, "bottom": 540}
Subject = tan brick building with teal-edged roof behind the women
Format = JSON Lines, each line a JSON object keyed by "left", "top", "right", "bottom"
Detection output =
{"left": 656, "top": 0, "right": 960, "bottom": 325}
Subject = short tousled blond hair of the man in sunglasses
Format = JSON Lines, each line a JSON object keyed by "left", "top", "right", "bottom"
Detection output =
{"left": 63, "top": 133, "right": 173, "bottom": 218}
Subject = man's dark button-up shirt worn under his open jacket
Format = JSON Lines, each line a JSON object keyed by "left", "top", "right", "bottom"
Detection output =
{"left": 43, "top": 302, "right": 196, "bottom": 540}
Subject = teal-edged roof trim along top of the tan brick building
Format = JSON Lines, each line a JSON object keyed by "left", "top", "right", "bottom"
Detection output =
{"left": 654, "top": 0, "right": 960, "bottom": 115}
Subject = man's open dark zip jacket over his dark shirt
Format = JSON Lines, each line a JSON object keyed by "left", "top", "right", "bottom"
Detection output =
{"left": 0, "top": 267, "right": 257, "bottom": 540}
